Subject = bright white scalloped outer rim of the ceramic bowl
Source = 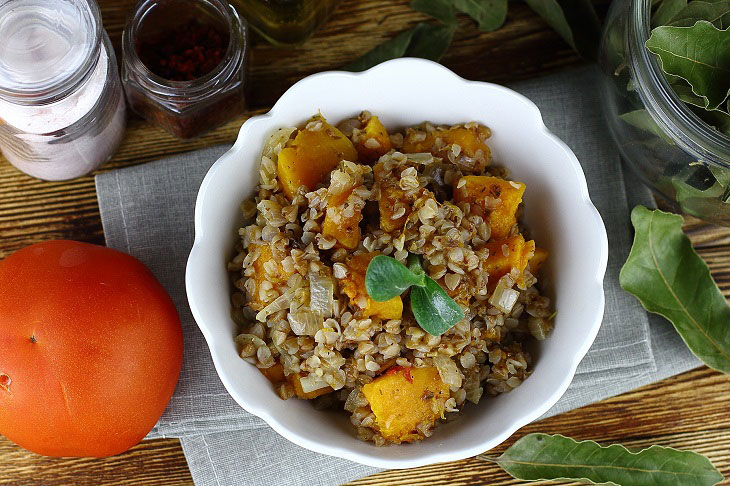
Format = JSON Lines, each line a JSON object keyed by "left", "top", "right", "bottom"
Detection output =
{"left": 186, "top": 58, "right": 608, "bottom": 468}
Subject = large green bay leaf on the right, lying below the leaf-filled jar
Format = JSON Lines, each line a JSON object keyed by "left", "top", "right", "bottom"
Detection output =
{"left": 619, "top": 206, "right": 730, "bottom": 373}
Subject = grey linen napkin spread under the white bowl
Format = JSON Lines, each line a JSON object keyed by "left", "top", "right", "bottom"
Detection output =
{"left": 96, "top": 68, "right": 698, "bottom": 486}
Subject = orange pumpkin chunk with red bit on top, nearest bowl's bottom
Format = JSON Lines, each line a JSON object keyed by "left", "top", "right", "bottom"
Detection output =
{"left": 362, "top": 366, "right": 450, "bottom": 443}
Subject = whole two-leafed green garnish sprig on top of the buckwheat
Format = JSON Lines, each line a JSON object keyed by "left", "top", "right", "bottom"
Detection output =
{"left": 365, "top": 254, "right": 464, "bottom": 336}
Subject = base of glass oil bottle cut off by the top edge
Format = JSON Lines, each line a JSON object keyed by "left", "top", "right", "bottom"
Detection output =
{"left": 231, "top": 0, "right": 340, "bottom": 45}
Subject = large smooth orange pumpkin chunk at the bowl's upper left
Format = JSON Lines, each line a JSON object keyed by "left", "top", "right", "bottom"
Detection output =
{"left": 277, "top": 115, "right": 357, "bottom": 199}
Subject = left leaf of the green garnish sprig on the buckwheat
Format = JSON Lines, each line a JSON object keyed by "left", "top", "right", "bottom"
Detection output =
{"left": 365, "top": 255, "right": 426, "bottom": 302}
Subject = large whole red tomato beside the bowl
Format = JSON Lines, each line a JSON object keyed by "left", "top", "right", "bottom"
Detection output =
{"left": 0, "top": 240, "right": 183, "bottom": 457}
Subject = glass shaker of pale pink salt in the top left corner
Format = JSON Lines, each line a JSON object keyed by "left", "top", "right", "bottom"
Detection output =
{"left": 0, "top": 0, "right": 126, "bottom": 180}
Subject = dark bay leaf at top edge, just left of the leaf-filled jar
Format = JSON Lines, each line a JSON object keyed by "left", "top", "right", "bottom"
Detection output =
{"left": 525, "top": 0, "right": 601, "bottom": 59}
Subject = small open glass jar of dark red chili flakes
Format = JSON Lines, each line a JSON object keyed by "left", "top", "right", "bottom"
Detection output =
{"left": 122, "top": 0, "right": 248, "bottom": 139}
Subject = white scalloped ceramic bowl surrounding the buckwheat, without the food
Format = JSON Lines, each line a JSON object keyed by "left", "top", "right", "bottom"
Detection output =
{"left": 186, "top": 59, "right": 608, "bottom": 468}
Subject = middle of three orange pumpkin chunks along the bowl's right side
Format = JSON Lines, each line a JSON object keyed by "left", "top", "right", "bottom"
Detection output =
{"left": 454, "top": 176, "right": 525, "bottom": 240}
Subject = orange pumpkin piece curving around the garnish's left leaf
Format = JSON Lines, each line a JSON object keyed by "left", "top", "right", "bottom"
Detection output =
{"left": 342, "top": 251, "right": 403, "bottom": 319}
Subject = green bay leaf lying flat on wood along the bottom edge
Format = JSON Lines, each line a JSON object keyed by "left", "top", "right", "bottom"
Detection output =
{"left": 496, "top": 434, "right": 724, "bottom": 486}
